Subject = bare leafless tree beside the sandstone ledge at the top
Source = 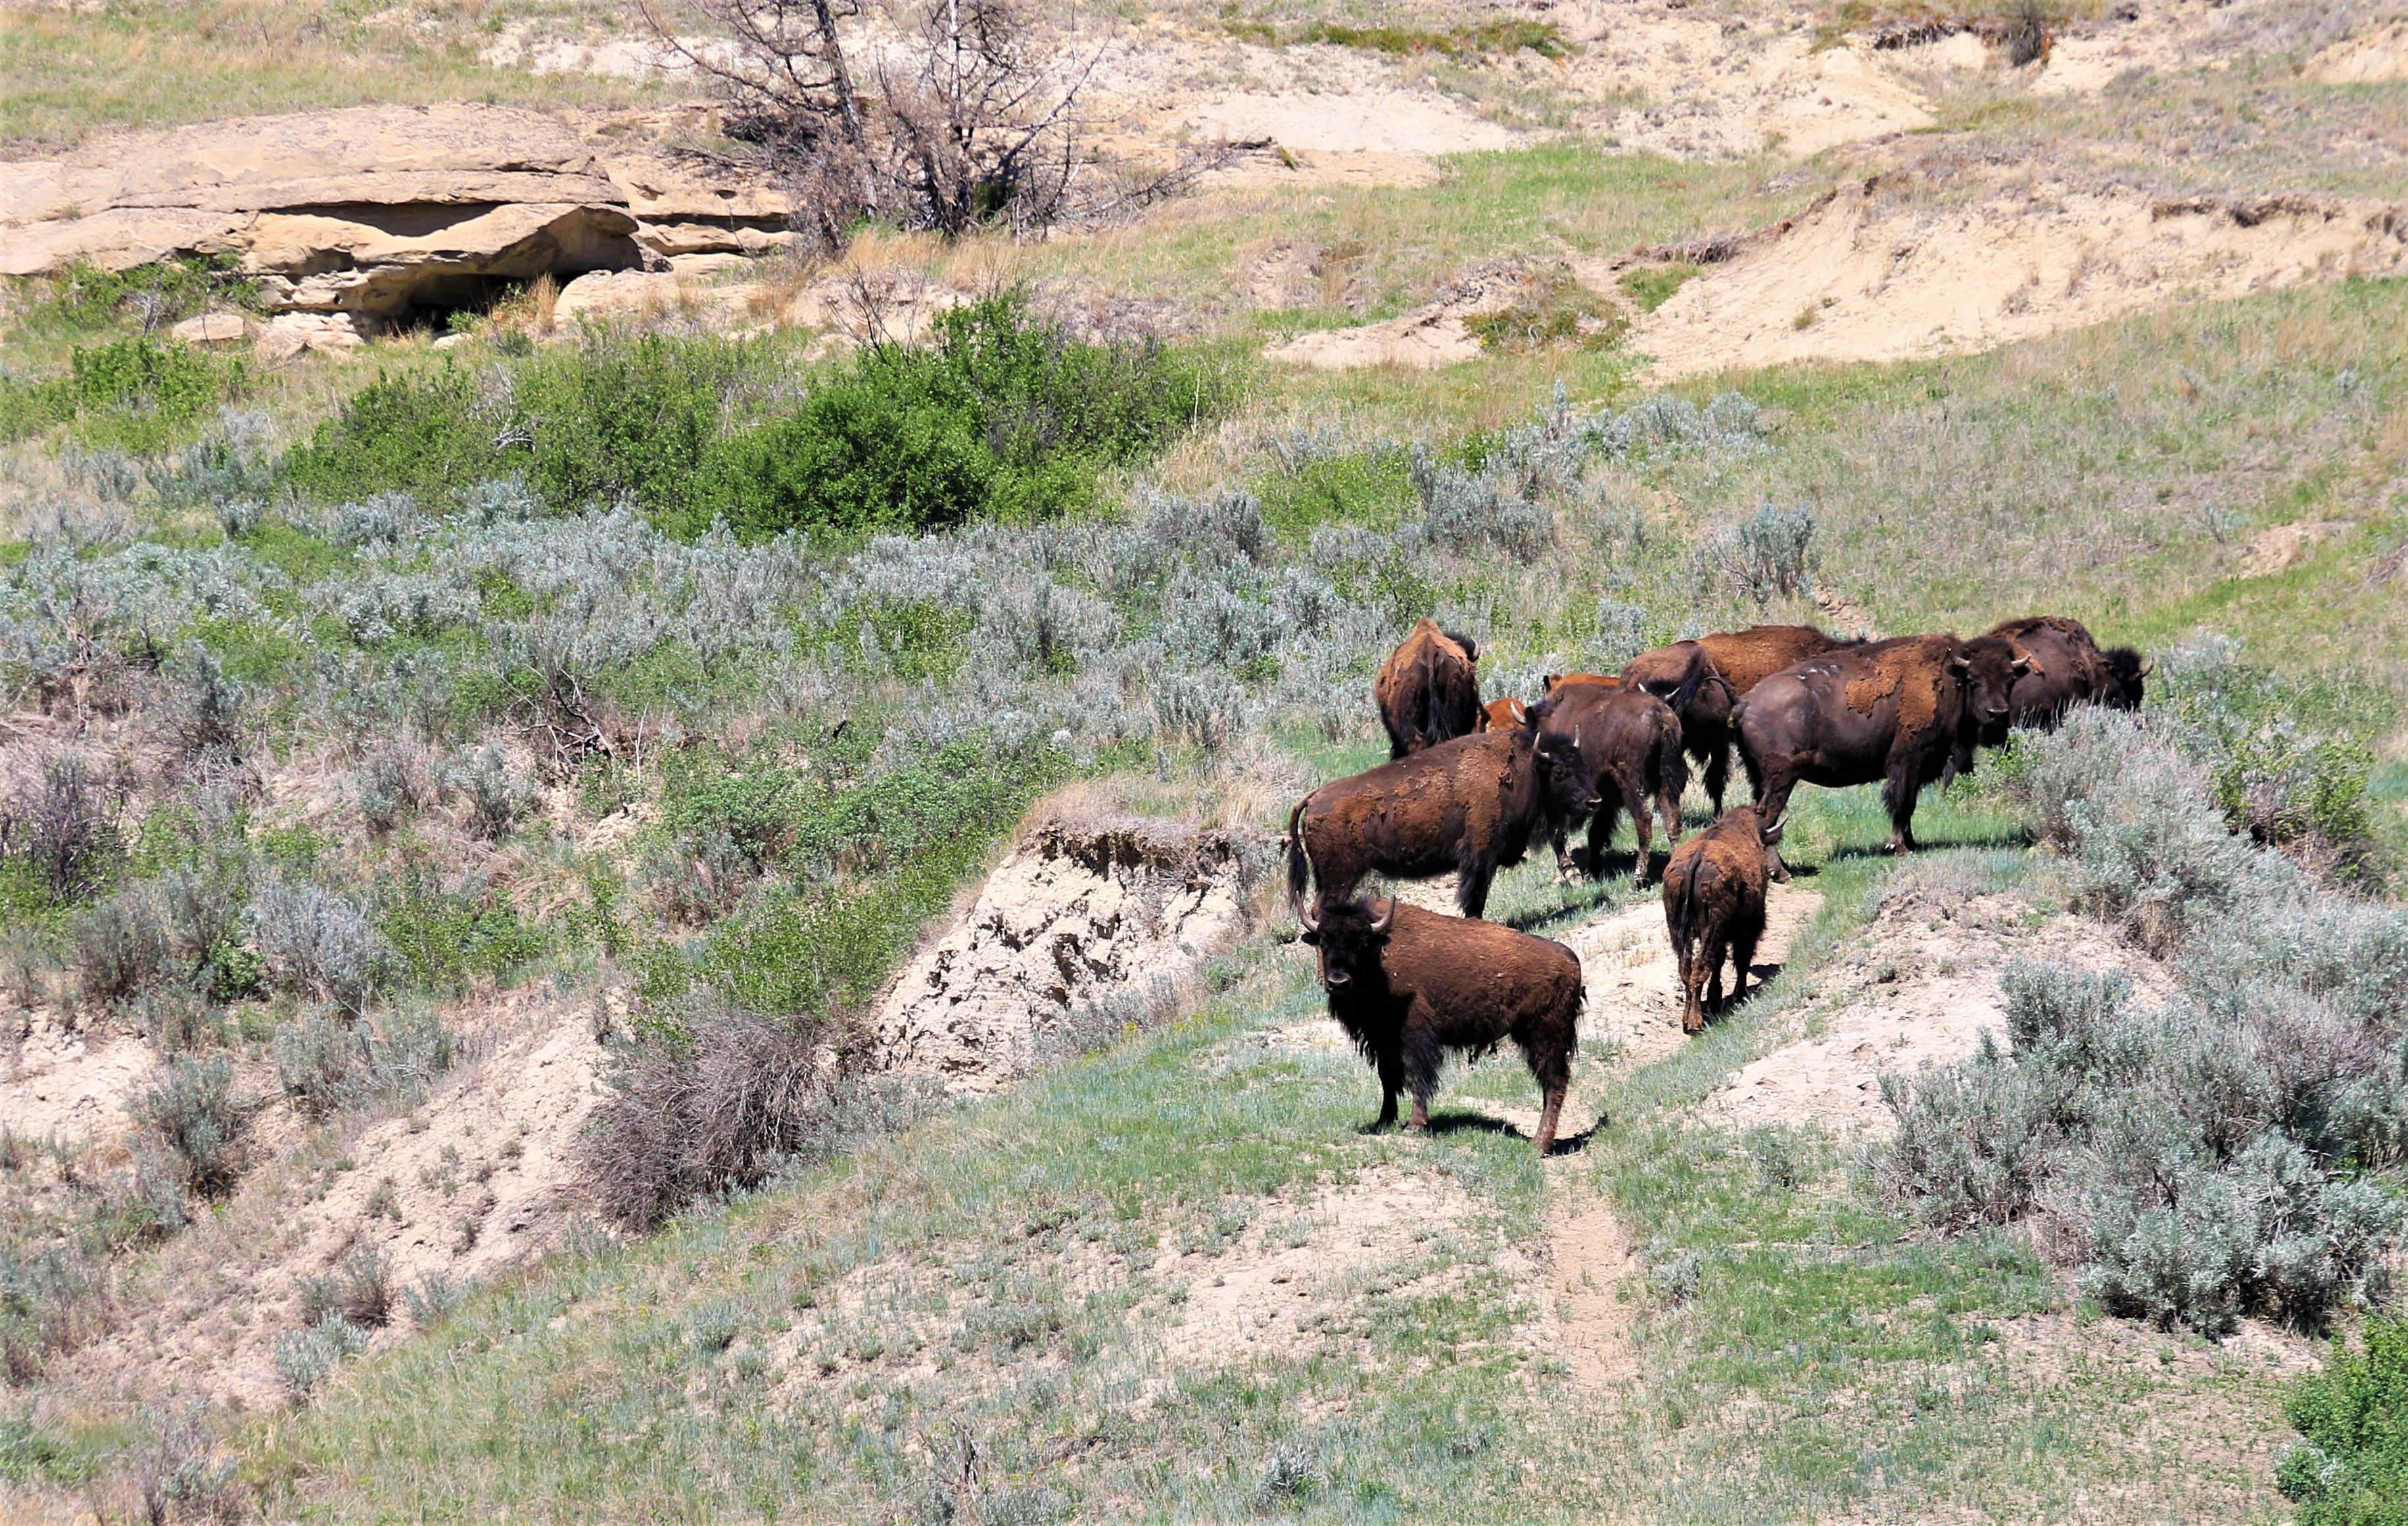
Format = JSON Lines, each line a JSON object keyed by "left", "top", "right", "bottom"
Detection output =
{"left": 640, "top": 0, "right": 1223, "bottom": 248}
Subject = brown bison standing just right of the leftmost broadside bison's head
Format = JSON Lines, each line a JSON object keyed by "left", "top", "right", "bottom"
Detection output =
{"left": 1529, "top": 681, "right": 1688, "bottom": 886}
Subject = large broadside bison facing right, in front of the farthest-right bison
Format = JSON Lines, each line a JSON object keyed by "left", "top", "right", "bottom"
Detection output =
{"left": 1739, "top": 635, "right": 2030, "bottom": 878}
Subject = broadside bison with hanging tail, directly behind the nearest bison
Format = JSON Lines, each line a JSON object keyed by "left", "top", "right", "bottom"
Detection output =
{"left": 1288, "top": 727, "right": 1541, "bottom": 917}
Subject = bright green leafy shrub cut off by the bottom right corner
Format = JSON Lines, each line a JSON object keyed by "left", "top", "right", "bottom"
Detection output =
{"left": 2276, "top": 1319, "right": 2408, "bottom": 1526}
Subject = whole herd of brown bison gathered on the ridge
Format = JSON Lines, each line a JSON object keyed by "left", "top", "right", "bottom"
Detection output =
{"left": 1288, "top": 616, "right": 2148, "bottom": 1153}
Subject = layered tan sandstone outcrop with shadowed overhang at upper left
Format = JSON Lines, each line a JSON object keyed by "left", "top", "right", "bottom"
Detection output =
{"left": 0, "top": 106, "right": 790, "bottom": 325}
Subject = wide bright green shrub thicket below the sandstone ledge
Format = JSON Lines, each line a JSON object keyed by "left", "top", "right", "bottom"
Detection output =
{"left": 284, "top": 296, "right": 1225, "bottom": 539}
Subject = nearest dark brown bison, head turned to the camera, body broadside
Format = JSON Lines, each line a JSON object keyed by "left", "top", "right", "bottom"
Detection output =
{"left": 1296, "top": 900, "right": 1584, "bottom": 1155}
